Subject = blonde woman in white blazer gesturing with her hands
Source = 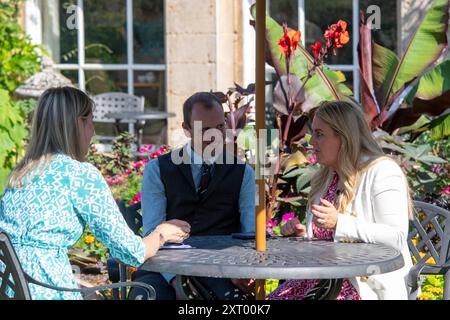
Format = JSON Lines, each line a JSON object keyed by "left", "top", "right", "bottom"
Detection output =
{"left": 269, "top": 101, "right": 412, "bottom": 300}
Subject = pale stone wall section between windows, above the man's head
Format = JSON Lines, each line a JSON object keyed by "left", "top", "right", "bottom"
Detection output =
{"left": 165, "top": 0, "right": 242, "bottom": 147}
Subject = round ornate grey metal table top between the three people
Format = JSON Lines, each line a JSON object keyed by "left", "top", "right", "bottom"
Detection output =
{"left": 141, "top": 236, "right": 404, "bottom": 279}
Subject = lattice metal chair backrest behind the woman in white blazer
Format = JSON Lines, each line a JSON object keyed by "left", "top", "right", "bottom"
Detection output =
{"left": 408, "top": 201, "right": 450, "bottom": 265}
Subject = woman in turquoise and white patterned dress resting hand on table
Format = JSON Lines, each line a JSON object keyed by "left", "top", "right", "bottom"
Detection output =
{"left": 0, "top": 87, "right": 190, "bottom": 299}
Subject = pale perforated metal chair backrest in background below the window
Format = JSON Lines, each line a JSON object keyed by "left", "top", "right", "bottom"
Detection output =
{"left": 92, "top": 92, "right": 144, "bottom": 123}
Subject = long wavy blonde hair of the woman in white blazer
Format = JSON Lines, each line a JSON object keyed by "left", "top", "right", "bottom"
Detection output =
{"left": 308, "top": 101, "right": 413, "bottom": 217}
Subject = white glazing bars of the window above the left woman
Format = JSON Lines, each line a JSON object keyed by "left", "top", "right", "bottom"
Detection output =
{"left": 55, "top": 0, "right": 166, "bottom": 101}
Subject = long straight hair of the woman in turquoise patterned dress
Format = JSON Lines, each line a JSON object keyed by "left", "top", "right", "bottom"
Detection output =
{"left": 8, "top": 87, "right": 94, "bottom": 188}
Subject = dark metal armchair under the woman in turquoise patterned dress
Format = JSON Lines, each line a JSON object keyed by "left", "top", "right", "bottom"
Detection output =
{"left": 0, "top": 230, "right": 156, "bottom": 300}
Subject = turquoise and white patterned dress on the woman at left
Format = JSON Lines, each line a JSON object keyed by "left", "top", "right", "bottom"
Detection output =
{"left": 0, "top": 154, "right": 145, "bottom": 299}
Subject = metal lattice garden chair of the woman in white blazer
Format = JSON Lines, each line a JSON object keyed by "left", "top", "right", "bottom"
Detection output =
{"left": 408, "top": 201, "right": 450, "bottom": 300}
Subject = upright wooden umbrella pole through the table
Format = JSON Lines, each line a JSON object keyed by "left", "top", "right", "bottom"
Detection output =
{"left": 255, "top": 0, "right": 266, "bottom": 300}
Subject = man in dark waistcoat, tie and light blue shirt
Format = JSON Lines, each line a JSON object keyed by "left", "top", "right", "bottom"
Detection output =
{"left": 130, "top": 92, "right": 255, "bottom": 300}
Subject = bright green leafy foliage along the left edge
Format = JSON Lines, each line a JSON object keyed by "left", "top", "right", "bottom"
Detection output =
{"left": 0, "top": 0, "right": 39, "bottom": 194}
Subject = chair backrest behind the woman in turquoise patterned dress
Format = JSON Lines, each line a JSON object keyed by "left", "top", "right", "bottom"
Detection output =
{"left": 0, "top": 230, "right": 31, "bottom": 300}
